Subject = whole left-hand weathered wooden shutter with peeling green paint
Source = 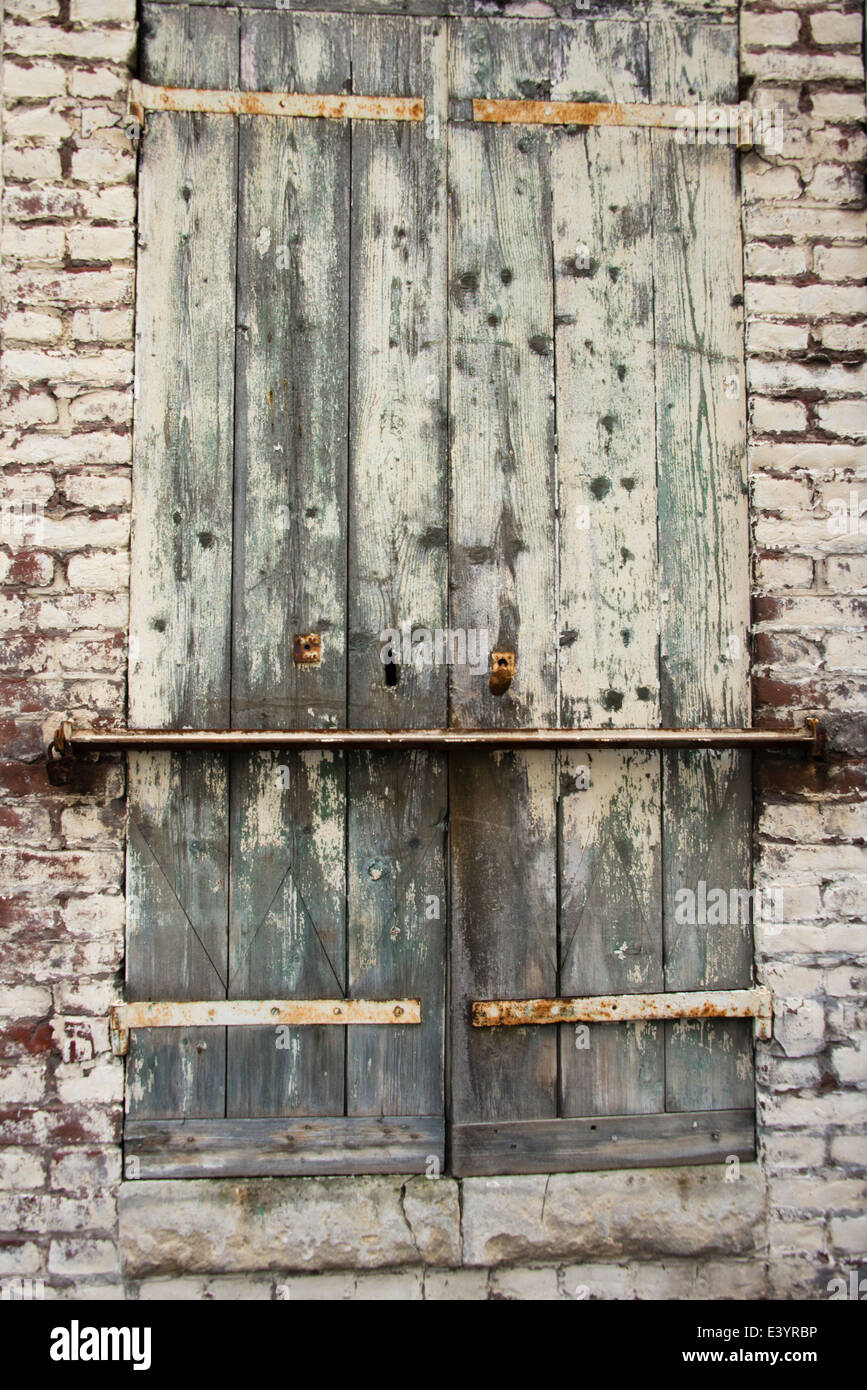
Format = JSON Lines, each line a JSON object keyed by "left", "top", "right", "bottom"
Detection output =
{"left": 126, "top": 6, "right": 447, "bottom": 1176}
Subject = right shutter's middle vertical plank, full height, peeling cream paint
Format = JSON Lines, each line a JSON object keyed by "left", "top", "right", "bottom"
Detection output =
{"left": 552, "top": 19, "right": 664, "bottom": 1115}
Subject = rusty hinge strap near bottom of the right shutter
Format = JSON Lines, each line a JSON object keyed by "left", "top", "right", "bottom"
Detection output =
{"left": 472, "top": 987, "right": 773, "bottom": 1038}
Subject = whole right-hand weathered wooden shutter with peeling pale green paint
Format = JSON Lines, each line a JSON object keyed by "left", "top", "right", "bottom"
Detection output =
{"left": 449, "top": 19, "right": 753, "bottom": 1173}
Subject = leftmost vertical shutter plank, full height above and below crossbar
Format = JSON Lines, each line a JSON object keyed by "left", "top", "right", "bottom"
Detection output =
{"left": 126, "top": 6, "right": 238, "bottom": 1119}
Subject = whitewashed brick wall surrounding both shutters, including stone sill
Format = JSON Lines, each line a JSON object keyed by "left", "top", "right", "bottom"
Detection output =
{"left": 0, "top": 0, "right": 867, "bottom": 1298}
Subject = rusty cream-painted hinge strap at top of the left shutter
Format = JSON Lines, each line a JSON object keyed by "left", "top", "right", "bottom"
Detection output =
{"left": 129, "top": 81, "right": 424, "bottom": 125}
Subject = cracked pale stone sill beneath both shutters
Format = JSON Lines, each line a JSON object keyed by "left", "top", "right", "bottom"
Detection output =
{"left": 119, "top": 1163, "right": 764, "bottom": 1277}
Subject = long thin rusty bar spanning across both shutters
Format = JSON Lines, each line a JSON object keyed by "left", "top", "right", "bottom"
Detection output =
{"left": 50, "top": 719, "right": 821, "bottom": 759}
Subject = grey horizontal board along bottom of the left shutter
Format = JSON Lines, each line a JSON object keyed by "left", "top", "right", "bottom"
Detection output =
{"left": 124, "top": 1115, "right": 445, "bottom": 1177}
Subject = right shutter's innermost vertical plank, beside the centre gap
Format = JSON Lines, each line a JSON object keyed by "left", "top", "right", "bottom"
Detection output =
{"left": 449, "top": 19, "right": 557, "bottom": 1123}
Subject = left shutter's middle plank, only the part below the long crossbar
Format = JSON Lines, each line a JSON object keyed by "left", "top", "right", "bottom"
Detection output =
{"left": 226, "top": 752, "right": 346, "bottom": 1119}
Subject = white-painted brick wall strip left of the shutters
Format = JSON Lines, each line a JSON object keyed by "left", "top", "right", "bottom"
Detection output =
{"left": 0, "top": 0, "right": 135, "bottom": 1287}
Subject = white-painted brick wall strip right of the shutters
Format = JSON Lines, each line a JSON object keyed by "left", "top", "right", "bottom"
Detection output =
{"left": 741, "top": 0, "right": 867, "bottom": 1297}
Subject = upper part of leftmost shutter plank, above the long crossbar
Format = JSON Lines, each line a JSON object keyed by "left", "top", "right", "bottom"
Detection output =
{"left": 129, "top": 8, "right": 238, "bottom": 728}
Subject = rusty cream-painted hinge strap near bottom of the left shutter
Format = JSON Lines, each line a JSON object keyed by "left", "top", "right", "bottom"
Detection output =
{"left": 108, "top": 999, "right": 421, "bottom": 1056}
